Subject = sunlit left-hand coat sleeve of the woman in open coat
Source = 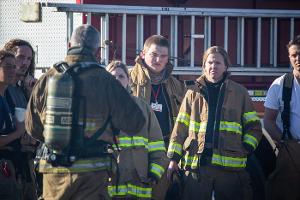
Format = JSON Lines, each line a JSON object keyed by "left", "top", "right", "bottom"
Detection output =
{"left": 167, "top": 90, "right": 193, "bottom": 163}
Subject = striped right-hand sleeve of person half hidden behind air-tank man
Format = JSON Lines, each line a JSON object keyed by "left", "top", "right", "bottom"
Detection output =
{"left": 147, "top": 105, "right": 169, "bottom": 180}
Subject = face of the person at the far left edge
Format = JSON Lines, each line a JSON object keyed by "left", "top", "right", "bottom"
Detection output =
{"left": 0, "top": 57, "right": 16, "bottom": 85}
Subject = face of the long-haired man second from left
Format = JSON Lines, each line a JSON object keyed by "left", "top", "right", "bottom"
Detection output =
{"left": 16, "top": 46, "right": 32, "bottom": 76}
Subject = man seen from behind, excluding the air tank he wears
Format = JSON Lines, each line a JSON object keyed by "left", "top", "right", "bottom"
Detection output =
{"left": 25, "top": 25, "right": 145, "bottom": 200}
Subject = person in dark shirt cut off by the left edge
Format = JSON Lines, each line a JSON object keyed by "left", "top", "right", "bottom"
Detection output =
{"left": 0, "top": 50, "right": 25, "bottom": 200}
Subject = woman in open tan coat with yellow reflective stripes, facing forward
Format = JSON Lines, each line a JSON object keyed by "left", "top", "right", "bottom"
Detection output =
{"left": 167, "top": 46, "right": 262, "bottom": 200}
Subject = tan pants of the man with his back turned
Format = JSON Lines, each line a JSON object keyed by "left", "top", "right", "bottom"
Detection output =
{"left": 43, "top": 170, "right": 108, "bottom": 200}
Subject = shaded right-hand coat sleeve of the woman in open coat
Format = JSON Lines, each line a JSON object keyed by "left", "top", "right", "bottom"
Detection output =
{"left": 242, "top": 88, "right": 262, "bottom": 153}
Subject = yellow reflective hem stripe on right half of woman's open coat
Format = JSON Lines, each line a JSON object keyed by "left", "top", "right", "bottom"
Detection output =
{"left": 212, "top": 154, "right": 247, "bottom": 168}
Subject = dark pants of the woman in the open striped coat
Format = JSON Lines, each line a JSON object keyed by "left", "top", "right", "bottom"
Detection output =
{"left": 183, "top": 166, "right": 253, "bottom": 200}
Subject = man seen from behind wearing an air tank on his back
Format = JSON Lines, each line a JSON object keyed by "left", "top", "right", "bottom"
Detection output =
{"left": 25, "top": 25, "right": 145, "bottom": 200}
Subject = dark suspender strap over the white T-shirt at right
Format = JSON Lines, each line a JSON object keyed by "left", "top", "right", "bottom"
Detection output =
{"left": 281, "top": 72, "right": 294, "bottom": 139}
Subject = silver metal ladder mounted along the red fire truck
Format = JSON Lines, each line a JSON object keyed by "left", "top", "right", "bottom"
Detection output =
{"left": 35, "top": 2, "right": 300, "bottom": 76}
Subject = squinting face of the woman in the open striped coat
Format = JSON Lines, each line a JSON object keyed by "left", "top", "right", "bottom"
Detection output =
{"left": 204, "top": 53, "right": 227, "bottom": 83}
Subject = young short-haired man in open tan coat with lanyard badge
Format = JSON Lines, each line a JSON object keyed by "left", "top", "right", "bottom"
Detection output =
{"left": 129, "top": 35, "right": 185, "bottom": 199}
